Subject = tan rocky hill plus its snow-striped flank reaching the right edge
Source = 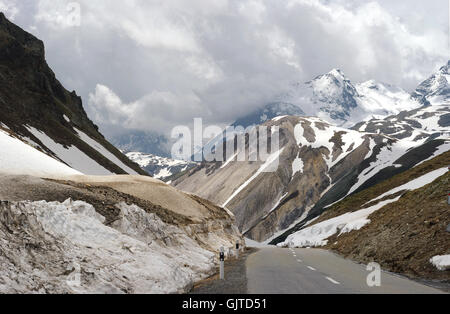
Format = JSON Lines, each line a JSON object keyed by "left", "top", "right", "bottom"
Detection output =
{"left": 173, "top": 117, "right": 450, "bottom": 243}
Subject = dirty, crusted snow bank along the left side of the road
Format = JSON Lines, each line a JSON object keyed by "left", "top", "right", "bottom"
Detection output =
{"left": 0, "top": 200, "right": 215, "bottom": 293}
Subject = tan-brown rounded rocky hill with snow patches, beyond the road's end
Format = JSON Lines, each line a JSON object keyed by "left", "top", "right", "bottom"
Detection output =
{"left": 173, "top": 117, "right": 395, "bottom": 241}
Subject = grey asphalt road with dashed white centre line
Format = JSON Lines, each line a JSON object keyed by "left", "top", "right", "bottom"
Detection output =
{"left": 246, "top": 247, "right": 444, "bottom": 294}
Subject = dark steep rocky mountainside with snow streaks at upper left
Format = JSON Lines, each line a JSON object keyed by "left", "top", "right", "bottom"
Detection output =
{"left": 0, "top": 13, "right": 146, "bottom": 174}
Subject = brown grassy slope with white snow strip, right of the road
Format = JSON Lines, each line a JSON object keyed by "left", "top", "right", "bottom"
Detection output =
{"left": 280, "top": 152, "right": 450, "bottom": 283}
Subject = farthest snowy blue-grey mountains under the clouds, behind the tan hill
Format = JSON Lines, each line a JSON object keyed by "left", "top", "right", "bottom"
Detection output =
{"left": 120, "top": 64, "right": 449, "bottom": 182}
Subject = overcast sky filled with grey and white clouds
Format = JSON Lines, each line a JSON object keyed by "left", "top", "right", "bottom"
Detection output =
{"left": 0, "top": 0, "right": 449, "bottom": 135}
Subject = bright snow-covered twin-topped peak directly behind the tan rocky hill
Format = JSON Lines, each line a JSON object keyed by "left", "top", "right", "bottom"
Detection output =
{"left": 237, "top": 69, "right": 421, "bottom": 127}
